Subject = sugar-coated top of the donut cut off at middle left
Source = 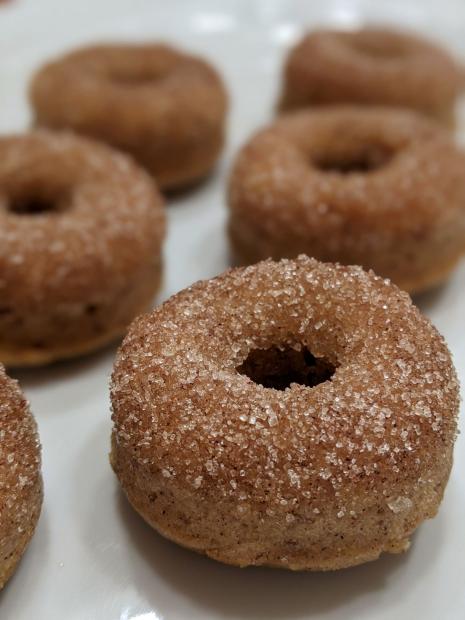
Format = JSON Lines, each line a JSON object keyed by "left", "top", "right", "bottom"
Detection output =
{"left": 0, "top": 131, "right": 165, "bottom": 304}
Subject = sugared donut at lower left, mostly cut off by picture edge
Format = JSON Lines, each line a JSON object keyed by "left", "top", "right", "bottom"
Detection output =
{"left": 0, "top": 364, "right": 42, "bottom": 589}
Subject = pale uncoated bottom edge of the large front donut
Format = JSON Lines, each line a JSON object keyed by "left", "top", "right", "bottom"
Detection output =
{"left": 109, "top": 435, "right": 452, "bottom": 572}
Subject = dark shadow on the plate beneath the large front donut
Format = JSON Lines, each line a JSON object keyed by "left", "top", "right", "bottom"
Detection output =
{"left": 115, "top": 492, "right": 432, "bottom": 619}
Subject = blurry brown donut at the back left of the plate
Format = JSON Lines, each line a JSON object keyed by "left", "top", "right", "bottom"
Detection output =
{"left": 30, "top": 44, "right": 227, "bottom": 190}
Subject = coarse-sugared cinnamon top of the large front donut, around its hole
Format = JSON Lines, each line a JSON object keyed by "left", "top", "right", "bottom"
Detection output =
{"left": 112, "top": 256, "right": 458, "bottom": 520}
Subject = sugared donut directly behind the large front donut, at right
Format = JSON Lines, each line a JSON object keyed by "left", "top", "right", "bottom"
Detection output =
{"left": 228, "top": 106, "right": 465, "bottom": 293}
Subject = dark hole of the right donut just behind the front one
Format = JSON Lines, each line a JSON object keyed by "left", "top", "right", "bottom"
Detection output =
{"left": 312, "top": 147, "right": 393, "bottom": 174}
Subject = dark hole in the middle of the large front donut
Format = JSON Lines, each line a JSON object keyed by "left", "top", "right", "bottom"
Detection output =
{"left": 236, "top": 346, "right": 336, "bottom": 390}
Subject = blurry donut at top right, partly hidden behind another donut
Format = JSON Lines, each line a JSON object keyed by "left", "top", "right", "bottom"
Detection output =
{"left": 279, "top": 27, "right": 463, "bottom": 125}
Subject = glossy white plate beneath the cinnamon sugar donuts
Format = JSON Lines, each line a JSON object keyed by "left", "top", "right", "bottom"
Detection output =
{"left": 0, "top": 0, "right": 465, "bottom": 620}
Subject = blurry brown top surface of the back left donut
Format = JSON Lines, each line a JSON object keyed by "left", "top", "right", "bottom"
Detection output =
{"left": 30, "top": 43, "right": 227, "bottom": 139}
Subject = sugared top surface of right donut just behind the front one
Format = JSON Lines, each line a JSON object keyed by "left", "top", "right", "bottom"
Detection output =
{"left": 229, "top": 106, "right": 465, "bottom": 240}
